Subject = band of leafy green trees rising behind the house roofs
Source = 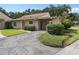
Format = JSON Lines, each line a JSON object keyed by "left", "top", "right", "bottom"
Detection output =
{"left": 0, "top": 5, "right": 71, "bottom": 19}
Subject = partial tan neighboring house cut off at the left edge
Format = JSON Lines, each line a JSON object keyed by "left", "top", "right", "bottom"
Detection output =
{"left": 0, "top": 12, "right": 12, "bottom": 29}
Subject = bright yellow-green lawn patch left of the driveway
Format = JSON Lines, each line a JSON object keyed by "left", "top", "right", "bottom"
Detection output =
{"left": 0, "top": 29, "right": 25, "bottom": 36}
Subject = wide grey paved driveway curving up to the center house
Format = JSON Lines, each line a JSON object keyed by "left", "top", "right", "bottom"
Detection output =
{"left": 0, "top": 31, "right": 62, "bottom": 55}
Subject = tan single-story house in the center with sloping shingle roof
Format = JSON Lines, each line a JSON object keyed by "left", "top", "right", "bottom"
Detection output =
{"left": 13, "top": 12, "right": 52, "bottom": 30}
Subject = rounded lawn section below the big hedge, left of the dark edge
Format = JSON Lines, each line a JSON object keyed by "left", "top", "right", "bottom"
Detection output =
{"left": 39, "top": 33, "right": 69, "bottom": 47}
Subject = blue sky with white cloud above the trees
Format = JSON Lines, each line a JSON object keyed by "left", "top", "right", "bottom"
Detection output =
{"left": 0, "top": 4, "right": 79, "bottom": 13}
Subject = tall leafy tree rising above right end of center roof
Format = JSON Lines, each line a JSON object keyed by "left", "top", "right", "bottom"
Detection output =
{"left": 43, "top": 5, "right": 71, "bottom": 16}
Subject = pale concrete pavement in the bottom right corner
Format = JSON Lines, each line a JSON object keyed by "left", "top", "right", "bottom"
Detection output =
{"left": 57, "top": 40, "right": 79, "bottom": 55}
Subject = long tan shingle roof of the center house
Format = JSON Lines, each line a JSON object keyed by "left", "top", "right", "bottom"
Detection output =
{"left": 15, "top": 12, "right": 51, "bottom": 20}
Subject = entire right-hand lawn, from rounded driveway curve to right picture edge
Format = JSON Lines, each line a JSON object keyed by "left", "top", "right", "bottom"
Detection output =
{"left": 39, "top": 26, "right": 79, "bottom": 47}
